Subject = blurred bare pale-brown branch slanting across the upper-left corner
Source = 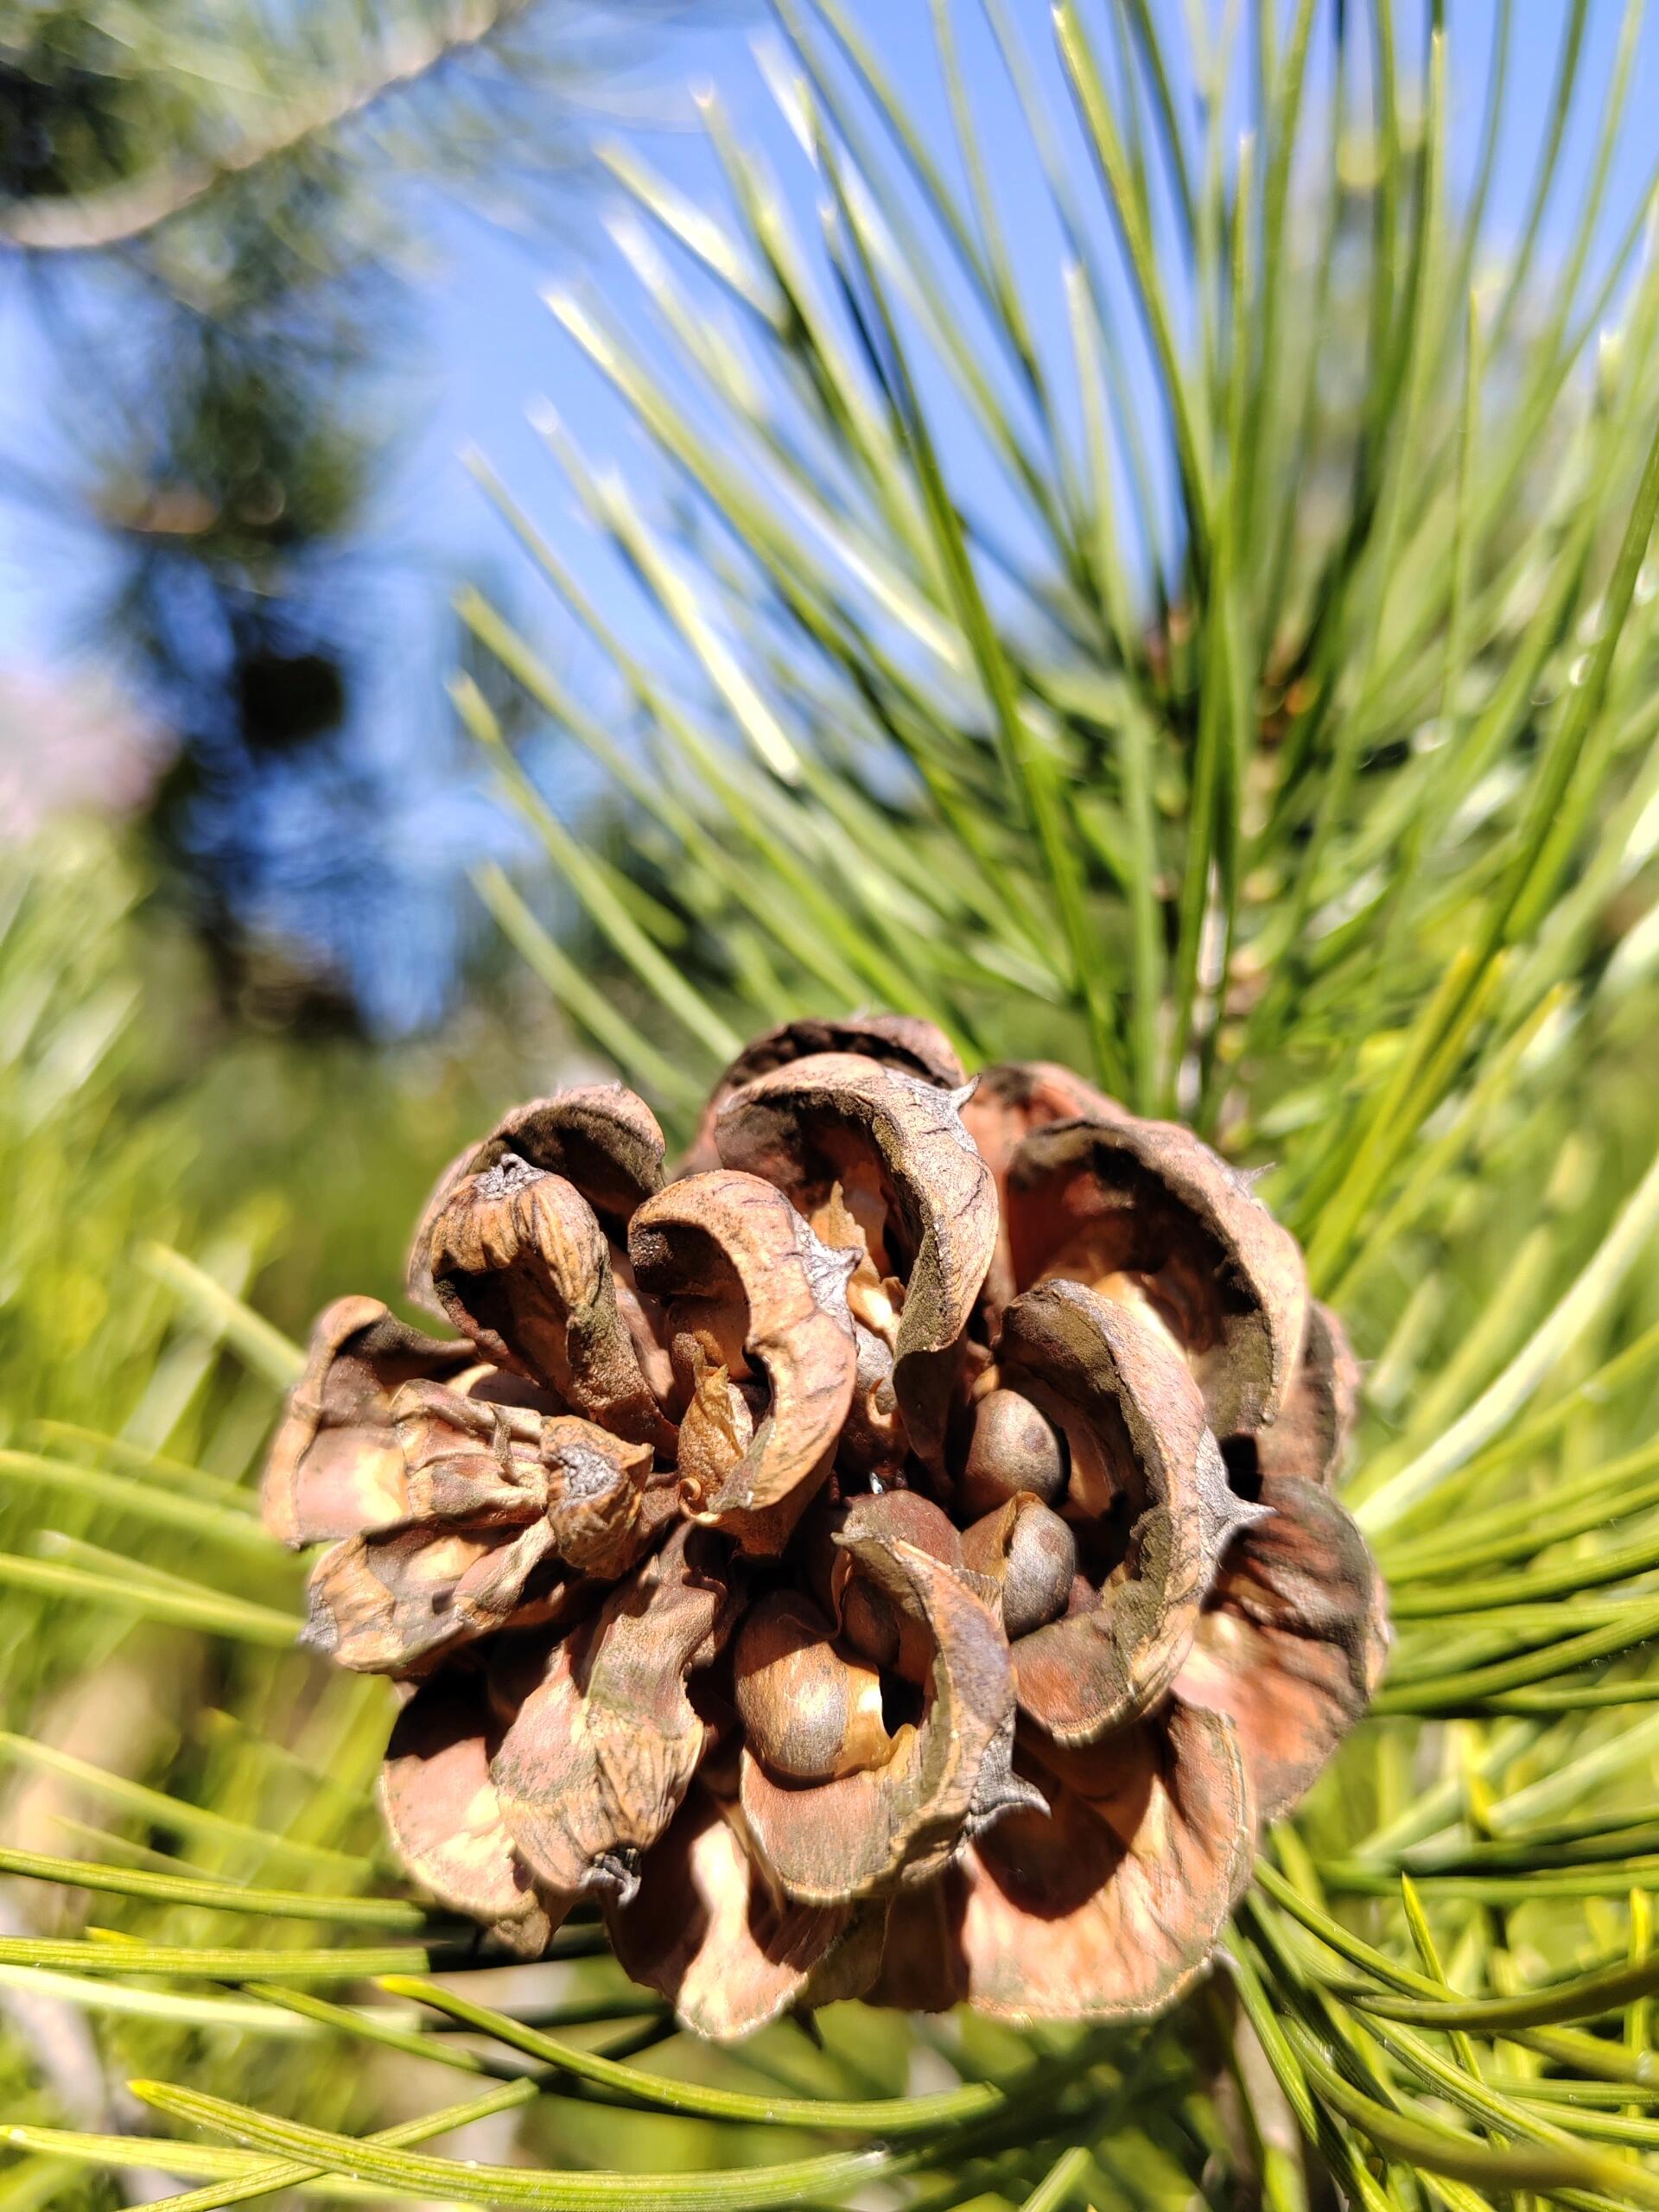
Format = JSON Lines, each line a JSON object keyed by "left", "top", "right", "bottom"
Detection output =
{"left": 0, "top": 0, "right": 536, "bottom": 254}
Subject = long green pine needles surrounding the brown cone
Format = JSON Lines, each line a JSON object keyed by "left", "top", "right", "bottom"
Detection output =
{"left": 0, "top": 0, "right": 1659, "bottom": 2212}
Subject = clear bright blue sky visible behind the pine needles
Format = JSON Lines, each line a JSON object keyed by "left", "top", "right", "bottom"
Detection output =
{"left": 0, "top": 0, "right": 1659, "bottom": 1024}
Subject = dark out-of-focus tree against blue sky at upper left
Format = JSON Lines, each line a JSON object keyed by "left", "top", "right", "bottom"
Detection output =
{"left": 0, "top": 0, "right": 703, "bottom": 1031}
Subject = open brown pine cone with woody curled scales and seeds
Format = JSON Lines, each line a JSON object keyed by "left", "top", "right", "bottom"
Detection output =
{"left": 265, "top": 1018, "right": 1387, "bottom": 2037}
